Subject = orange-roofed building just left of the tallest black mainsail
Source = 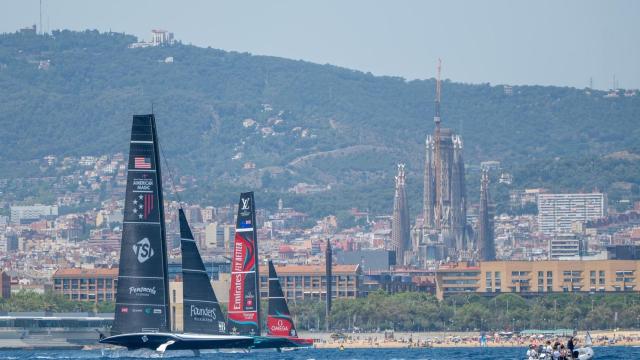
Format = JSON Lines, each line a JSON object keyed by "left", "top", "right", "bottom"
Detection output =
{"left": 52, "top": 268, "right": 118, "bottom": 302}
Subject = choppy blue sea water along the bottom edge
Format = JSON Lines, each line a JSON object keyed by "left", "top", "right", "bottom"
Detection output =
{"left": 0, "top": 347, "right": 640, "bottom": 360}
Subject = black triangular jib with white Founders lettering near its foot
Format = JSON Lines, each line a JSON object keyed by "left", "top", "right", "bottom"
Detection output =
{"left": 178, "top": 209, "right": 227, "bottom": 335}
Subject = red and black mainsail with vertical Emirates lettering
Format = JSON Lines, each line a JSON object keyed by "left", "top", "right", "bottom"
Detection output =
{"left": 229, "top": 191, "right": 260, "bottom": 336}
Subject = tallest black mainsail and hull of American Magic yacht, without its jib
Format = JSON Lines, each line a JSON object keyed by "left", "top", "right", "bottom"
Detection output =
{"left": 100, "top": 114, "right": 253, "bottom": 352}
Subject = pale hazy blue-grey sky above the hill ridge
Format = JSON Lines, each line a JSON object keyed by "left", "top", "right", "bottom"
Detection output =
{"left": 0, "top": 0, "right": 640, "bottom": 89}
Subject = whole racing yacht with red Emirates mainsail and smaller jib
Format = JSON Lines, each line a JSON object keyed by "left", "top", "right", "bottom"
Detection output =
{"left": 229, "top": 192, "right": 313, "bottom": 350}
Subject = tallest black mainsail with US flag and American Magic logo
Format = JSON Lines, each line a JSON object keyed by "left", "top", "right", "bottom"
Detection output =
{"left": 112, "top": 114, "right": 171, "bottom": 334}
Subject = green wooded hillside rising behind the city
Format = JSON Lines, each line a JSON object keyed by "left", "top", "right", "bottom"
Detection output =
{"left": 0, "top": 31, "right": 640, "bottom": 214}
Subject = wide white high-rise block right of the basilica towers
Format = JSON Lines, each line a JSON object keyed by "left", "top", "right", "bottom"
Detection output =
{"left": 538, "top": 193, "right": 605, "bottom": 235}
